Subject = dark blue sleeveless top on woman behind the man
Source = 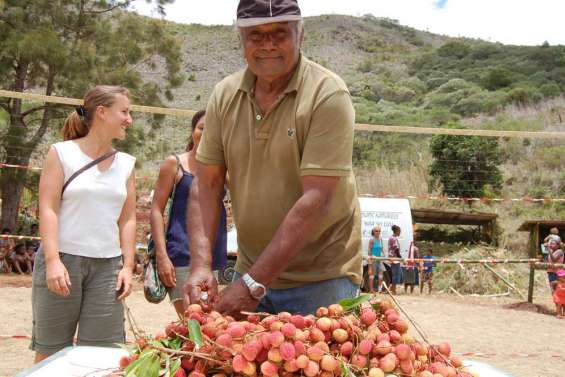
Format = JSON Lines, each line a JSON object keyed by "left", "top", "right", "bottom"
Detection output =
{"left": 166, "top": 157, "right": 227, "bottom": 271}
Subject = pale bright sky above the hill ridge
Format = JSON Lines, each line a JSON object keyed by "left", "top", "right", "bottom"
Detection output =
{"left": 132, "top": 0, "right": 565, "bottom": 45}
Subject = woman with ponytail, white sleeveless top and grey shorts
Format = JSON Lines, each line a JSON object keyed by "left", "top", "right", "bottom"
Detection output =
{"left": 31, "top": 86, "right": 135, "bottom": 362}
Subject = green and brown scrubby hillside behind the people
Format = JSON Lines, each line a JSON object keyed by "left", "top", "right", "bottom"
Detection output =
{"left": 5, "top": 15, "right": 565, "bottom": 249}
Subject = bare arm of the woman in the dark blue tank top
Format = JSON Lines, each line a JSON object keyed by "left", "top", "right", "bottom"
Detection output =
{"left": 150, "top": 156, "right": 177, "bottom": 287}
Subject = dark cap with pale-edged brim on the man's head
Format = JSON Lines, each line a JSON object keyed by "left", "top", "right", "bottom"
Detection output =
{"left": 236, "top": 0, "right": 302, "bottom": 27}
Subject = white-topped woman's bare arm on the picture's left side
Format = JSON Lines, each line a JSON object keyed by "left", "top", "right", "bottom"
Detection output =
{"left": 39, "top": 147, "right": 71, "bottom": 296}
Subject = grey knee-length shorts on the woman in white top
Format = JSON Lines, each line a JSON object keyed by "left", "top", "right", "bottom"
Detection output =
{"left": 30, "top": 251, "right": 125, "bottom": 355}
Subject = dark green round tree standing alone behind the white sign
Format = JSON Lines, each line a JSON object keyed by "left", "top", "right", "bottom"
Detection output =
{"left": 430, "top": 126, "right": 502, "bottom": 198}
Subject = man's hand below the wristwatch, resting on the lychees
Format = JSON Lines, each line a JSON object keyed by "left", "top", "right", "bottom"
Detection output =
{"left": 214, "top": 279, "right": 259, "bottom": 319}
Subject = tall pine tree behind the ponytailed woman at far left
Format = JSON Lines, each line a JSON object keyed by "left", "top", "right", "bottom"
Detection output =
{"left": 0, "top": 0, "right": 183, "bottom": 228}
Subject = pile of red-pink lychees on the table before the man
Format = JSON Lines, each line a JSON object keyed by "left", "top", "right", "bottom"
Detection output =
{"left": 120, "top": 300, "right": 476, "bottom": 377}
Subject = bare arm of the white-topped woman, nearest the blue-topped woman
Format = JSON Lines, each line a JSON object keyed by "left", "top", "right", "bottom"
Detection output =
{"left": 116, "top": 171, "right": 136, "bottom": 300}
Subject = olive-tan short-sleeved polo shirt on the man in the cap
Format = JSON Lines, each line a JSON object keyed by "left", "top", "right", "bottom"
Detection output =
{"left": 196, "top": 56, "right": 362, "bottom": 288}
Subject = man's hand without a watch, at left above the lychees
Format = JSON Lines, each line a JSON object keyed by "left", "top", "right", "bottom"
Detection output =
{"left": 183, "top": 267, "right": 218, "bottom": 309}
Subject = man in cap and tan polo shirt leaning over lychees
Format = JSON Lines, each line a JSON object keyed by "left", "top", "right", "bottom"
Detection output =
{"left": 185, "top": 0, "right": 362, "bottom": 317}
